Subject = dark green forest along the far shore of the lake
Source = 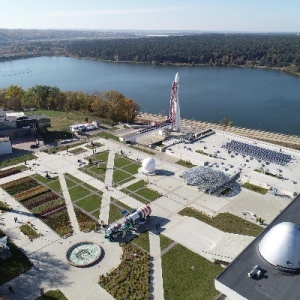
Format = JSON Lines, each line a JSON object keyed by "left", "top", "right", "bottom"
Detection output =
{"left": 0, "top": 33, "right": 300, "bottom": 75}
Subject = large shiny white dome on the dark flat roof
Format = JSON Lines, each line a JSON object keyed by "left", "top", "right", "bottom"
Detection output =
{"left": 258, "top": 222, "right": 300, "bottom": 270}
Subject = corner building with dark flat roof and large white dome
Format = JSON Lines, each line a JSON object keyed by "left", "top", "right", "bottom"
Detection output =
{"left": 215, "top": 196, "right": 300, "bottom": 300}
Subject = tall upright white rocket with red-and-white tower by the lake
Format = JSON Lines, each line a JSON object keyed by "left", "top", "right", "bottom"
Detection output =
{"left": 168, "top": 73, "right": 180, "bottom": 131}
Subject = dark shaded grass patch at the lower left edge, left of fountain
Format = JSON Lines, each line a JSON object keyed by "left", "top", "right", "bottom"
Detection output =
{"left": 0, "top": 230, "right": 33, "bottom": 285}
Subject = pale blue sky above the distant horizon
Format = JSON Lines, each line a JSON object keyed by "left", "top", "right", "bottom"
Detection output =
{"left": 0, "top": 0, "right": 300, "bottom": 33}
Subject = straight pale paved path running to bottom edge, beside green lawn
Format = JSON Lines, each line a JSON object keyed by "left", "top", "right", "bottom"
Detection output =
{"left": 149, "top": 231, "right": 164, "bottom": 300}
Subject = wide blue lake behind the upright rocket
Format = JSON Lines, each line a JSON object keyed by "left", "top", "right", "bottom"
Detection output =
{"left": 0, "top": 57, "right": 300, "bottom": 135}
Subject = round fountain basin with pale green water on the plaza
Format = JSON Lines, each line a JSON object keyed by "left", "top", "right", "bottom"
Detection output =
{"left": 66, "top": 242, "right": 102, "bottom": 267}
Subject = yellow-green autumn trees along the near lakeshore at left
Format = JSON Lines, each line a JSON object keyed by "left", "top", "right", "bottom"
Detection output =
{"left": 0, "top": 85, "right": 140, "bottom": 123}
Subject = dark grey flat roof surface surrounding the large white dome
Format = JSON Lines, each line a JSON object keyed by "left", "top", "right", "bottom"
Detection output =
{"left": 216, "top": 196, "right": 300, "bottom": 300}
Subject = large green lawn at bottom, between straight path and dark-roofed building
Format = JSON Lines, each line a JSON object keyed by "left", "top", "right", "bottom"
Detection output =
{"left": 162, "top": 244, "right": 223, "bottom": 300}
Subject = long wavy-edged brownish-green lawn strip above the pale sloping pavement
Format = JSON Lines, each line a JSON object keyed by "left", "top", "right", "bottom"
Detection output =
{"left": 179, "top": 207, "right": 263, "bottom": 236}
